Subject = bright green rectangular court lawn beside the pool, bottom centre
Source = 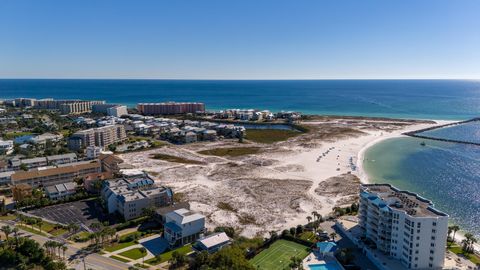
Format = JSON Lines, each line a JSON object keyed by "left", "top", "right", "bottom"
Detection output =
{"left": 250, "top": 239, "right": 310, "bottom": 269}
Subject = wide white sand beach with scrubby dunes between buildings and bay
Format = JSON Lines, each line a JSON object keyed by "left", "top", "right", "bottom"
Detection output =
{"left": 121, "top": 118, "right": 454, "bottom": 236}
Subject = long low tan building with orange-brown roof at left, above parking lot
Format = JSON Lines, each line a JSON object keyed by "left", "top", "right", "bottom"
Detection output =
{"left": 11, "top": 160, "right": 102, "bottom": 187}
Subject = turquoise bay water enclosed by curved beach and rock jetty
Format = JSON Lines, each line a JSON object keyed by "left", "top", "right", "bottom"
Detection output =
{"left": 363, "top": 137, "right": 480, "bottom": 237}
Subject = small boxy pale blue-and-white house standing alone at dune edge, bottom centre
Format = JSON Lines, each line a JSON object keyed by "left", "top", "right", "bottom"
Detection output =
{"left": 164, "top": 208, "right": 205, "bottom": 247}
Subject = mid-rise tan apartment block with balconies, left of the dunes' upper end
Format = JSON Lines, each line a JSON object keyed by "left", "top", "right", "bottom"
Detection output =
{"left": 68, "top": 125, "right": 127, "bottom": 151}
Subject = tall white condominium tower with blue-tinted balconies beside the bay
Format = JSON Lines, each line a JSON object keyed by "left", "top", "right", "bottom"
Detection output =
{"left": 359, "top": 184, "right": 448, "bottom": 269}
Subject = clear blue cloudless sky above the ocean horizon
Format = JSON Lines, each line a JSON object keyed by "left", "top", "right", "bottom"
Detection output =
{"left": 0, "top": 0, "right": 480, "bottom": 79}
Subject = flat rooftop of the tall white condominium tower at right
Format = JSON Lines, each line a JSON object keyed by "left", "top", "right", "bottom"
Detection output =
{"left": 362, "top": 184, "right": 447, "bottom": 217}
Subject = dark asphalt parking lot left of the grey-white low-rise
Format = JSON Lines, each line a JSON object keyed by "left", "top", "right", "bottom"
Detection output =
{"left": 29, "top": 199, "right": 110, "bottom": 226}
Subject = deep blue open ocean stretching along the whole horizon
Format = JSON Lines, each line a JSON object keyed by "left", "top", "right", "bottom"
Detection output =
{"left": 0, "top": 80, "right": 480, "bottom": 120}
